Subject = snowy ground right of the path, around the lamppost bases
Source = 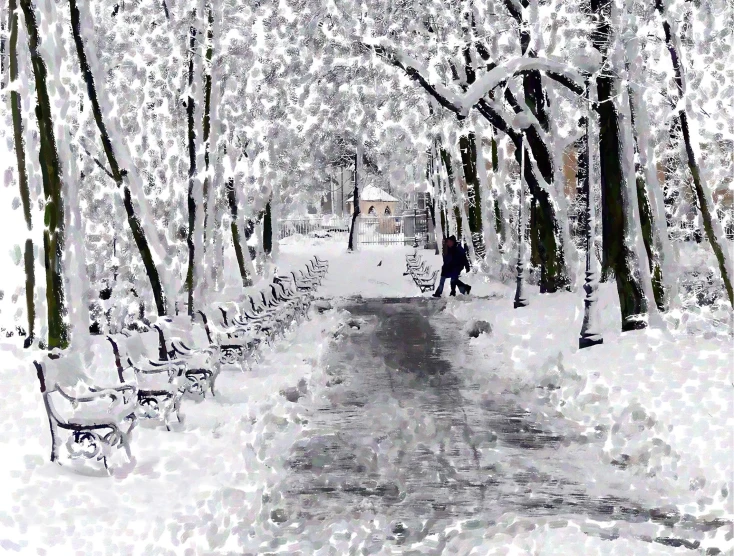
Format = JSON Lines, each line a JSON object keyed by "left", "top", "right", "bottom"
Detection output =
{"left": 446, "top": 276, "right": 734, "bottom": 520}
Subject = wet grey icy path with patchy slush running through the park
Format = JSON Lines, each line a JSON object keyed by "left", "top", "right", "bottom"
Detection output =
{"left": 271, "top": 299, "right": 721, "bottom": 554}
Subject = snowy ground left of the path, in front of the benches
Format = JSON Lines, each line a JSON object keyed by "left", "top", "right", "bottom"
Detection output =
{"left": 0, "top": 311, "right": 354, "bottom": 555}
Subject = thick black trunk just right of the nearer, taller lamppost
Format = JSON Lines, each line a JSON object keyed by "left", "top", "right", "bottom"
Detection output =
{"left": 591, "top": 0, "right": 648, "bottom": 331}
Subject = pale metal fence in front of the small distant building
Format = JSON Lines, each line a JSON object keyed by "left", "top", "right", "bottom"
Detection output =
{"left": 280, "top": 213, "right": 432, "bottom": 247}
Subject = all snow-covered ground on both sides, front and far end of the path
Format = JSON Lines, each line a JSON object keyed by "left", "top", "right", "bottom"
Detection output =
{"left": 0, "top": 239, "right": 734, "bottom": 555}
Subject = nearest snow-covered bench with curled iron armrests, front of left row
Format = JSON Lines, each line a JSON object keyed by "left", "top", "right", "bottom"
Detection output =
{"left": 33, "top": 350, "right": 137, "bottom": 473}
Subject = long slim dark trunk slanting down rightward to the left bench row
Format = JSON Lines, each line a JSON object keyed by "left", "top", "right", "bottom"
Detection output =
{"left": 69, "top": 0, "right": 168, "bottom": 316}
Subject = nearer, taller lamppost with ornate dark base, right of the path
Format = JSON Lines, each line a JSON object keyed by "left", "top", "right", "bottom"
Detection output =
{"left": 579, "top": 81, "right": 604, "bottom": 349}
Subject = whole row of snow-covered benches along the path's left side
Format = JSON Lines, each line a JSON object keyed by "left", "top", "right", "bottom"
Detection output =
{"left": 34, "top": 257, "right": 328, "bottom": 472}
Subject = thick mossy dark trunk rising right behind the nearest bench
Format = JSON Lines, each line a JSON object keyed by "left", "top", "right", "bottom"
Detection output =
{"left": 20, "top": 0, "right": 70, "bottom": 349}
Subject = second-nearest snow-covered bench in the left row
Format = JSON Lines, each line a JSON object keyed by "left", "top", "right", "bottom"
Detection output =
{"left": 107, "top": 330, "right": 189, "bottom": 430}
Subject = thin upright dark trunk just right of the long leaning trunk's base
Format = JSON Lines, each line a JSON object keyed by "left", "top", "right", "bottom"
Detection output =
{"left": 186, "top": 21, "right": 197, "bottom": 316}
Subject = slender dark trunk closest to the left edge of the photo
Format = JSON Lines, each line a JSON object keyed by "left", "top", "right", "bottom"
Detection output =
{"left": 8, "top": 0, "right": 36, "bottom": 347}
